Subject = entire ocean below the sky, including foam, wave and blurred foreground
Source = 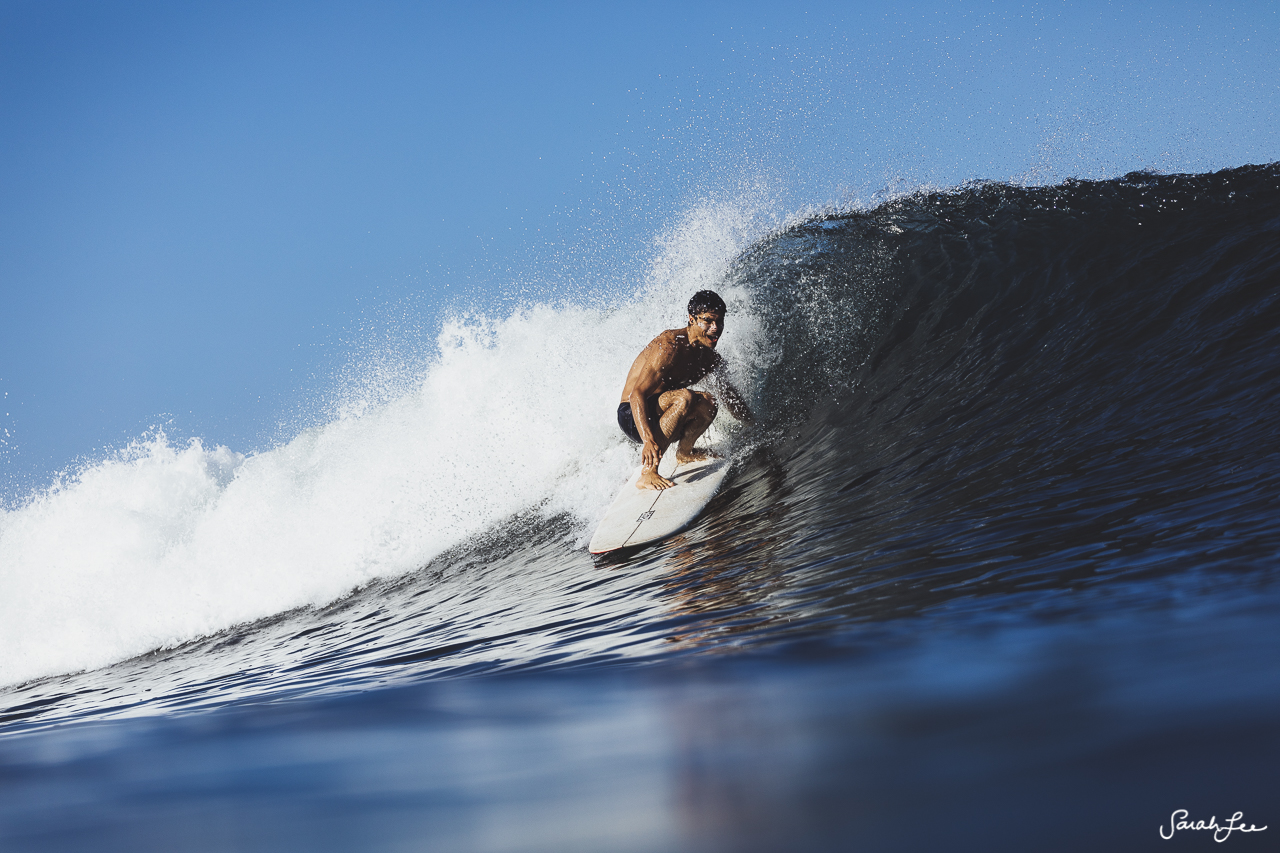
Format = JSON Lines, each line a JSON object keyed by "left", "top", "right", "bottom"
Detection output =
{"left": 0, "top": 164, "right": 1280, "bottom": 852}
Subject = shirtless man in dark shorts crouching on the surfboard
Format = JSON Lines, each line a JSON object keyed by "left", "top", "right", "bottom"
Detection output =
{"left": 618, "top": 291, "right": 754, "bottom": 489}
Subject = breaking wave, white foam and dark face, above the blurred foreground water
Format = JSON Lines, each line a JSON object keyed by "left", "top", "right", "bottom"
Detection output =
{"left": 0, "top": 165, "right": 1280, "bottom": 726}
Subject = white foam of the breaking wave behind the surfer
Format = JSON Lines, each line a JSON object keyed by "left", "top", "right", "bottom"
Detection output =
{"left": 0, "top": 194, "right": 769, "bottom": 684}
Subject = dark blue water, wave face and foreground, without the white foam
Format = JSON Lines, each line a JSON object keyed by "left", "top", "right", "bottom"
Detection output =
{"left": 0, "top": 165, "right": 1280, "bottom": 850}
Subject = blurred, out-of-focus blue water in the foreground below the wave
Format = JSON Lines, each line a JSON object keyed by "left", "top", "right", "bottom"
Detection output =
{"left": 0, "top": 599, "right": 1280, "bottom": 852}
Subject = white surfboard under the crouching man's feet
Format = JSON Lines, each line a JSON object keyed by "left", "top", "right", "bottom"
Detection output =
{"left": 589, "top": 453, "right": 728, "bottom": 553}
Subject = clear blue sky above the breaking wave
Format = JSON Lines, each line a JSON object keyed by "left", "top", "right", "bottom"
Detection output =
{"left": 0, "top": 1, "right": 1280, "bottom": 494}
